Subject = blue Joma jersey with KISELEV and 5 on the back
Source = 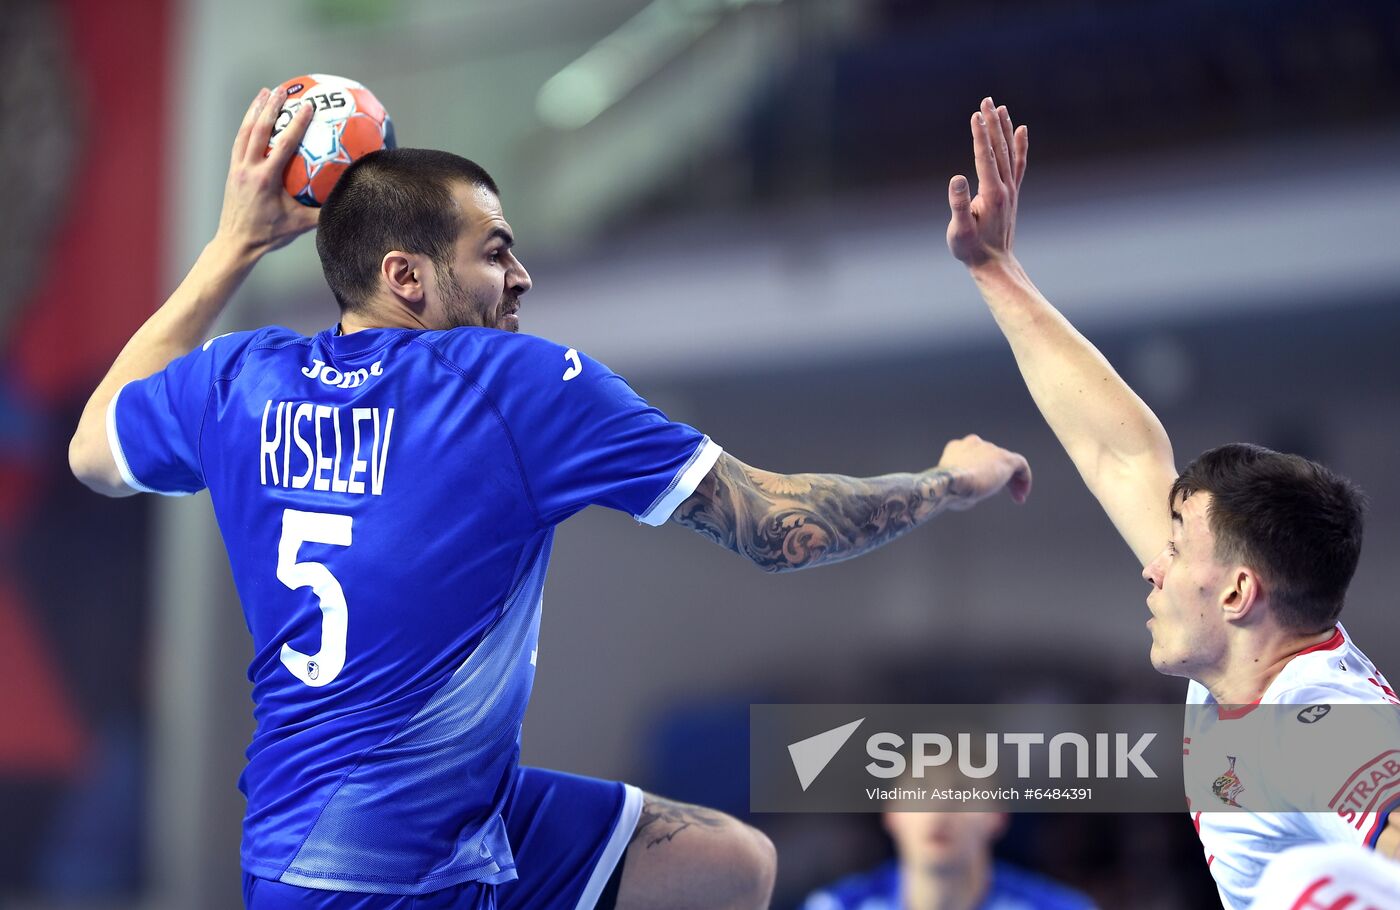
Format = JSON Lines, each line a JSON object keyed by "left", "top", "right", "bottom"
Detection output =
{"left": 108, "top": 328, "right": 720, "bottom": 895}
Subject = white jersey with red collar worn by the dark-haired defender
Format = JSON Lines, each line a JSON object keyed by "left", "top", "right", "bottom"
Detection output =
{"left": 1182, "top": 626, "right": 1400, "bottom": 910}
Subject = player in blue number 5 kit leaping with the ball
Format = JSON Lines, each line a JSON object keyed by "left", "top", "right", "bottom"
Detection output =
{"left": 70, "top": 91, "right": 1030, "bottom": 910}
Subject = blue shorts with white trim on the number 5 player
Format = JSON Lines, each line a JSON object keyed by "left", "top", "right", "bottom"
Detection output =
{"left": 244, "top": 767, "right": 641, "bottom": 910}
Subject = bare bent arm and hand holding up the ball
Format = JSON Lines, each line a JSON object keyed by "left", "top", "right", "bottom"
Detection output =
{"left": 69, "top": 90, "right": 318, "bottom": 496}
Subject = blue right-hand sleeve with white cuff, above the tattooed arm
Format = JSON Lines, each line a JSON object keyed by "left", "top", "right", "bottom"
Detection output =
{"left": 490, "top": 342, "right": 721, "bottom": 525}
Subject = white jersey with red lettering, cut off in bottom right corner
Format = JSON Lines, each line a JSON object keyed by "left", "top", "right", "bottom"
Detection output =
{"left": 1253, "top": 844, "right": 1400, "bottom": 910}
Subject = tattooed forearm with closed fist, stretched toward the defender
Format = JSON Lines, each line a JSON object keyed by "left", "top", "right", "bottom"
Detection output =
{"left": 671, "top": 435, "right": 1030, "bottom": 573}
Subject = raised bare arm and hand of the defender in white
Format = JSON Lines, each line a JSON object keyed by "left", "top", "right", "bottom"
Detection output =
{"left": 948, "top": 98, "right": 1176, "bottom": 564}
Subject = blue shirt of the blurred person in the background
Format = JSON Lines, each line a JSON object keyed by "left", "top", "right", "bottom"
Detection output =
{"left": 802, "top": 860, "right": 1093, "bottom": 910}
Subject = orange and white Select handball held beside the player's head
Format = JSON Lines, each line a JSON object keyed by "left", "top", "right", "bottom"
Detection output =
{"left": 267, "top": 73, "right": 395, "bottom": 206}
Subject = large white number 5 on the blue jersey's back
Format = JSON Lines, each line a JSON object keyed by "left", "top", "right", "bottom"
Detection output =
{"left": 277, "top": 508, "right": 351, "bottom": 687}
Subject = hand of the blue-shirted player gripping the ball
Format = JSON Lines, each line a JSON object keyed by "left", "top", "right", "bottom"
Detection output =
{"left": 216, "top": 88, "right": 321, "bottom": 255}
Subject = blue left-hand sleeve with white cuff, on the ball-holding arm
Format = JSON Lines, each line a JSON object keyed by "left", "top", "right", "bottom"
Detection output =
{"left": 106, "top": 333, "right": 257, "bottom": 496}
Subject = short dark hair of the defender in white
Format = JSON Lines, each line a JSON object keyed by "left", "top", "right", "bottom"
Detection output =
{"left": 1169, "top": 442, "right": 1366, "bottom": 634}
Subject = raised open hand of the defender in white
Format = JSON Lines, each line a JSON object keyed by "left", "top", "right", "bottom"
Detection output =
{"left": 948, "top": 98, "right": 1030, "bottom": 267}
